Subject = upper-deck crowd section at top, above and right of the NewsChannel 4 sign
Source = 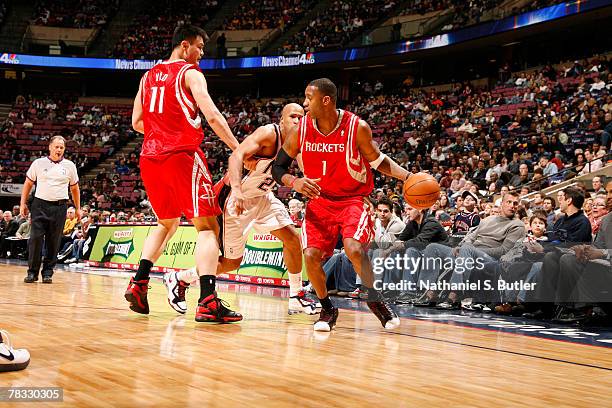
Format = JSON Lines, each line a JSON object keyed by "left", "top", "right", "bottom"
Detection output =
{"left": 281, "top": 0, "right": 397, "bottom": 54}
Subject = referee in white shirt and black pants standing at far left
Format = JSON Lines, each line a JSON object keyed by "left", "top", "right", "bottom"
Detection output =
{"left": 19, "top": 136, "right": 81, "bottom": 283}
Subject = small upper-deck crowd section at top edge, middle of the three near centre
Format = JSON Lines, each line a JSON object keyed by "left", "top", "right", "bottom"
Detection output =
{"left": 222, "top": 0, "right": 315, "bottom": 31}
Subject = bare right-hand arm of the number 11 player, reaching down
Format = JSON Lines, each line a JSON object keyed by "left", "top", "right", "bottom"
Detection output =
{"left": 185, "top": 69, "right": 238, "bottom": 150}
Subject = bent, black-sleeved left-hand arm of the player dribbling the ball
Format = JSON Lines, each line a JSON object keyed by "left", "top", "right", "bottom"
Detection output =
{"left": 272, "top": 120, "right": 321, "bottom": 198}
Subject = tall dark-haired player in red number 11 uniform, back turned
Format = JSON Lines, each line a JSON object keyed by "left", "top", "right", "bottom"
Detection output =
{"left": 125, "top": 25, "right": 242, "bottom": 322}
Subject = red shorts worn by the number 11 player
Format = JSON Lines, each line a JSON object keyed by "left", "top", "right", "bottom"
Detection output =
{"left": 140, "top": 149, "right": 221, "bottom": 220}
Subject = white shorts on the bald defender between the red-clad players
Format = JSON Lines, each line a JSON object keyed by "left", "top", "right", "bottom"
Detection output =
{"left": 221, "top": 192, "right": 293, "bottom": 259}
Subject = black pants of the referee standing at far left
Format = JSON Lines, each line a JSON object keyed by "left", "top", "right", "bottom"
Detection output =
{"left": 28, "top": 198, "right": 66, "bottom": 277}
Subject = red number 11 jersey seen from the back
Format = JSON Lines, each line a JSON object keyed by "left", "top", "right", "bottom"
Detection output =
{"left": 141, "top": 60, "right": 204, "bottom": 157}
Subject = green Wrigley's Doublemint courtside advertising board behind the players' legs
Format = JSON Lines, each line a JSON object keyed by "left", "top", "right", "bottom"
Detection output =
{"left": 87, "top": 224, "right": 307, "bottom": 286}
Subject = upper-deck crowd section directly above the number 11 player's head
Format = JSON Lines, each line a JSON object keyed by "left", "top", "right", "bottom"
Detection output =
{"left": 109, "top": 0, "right": 221, "bottom": 59}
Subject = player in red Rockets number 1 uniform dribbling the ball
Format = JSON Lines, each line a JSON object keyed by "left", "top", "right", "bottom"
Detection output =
{"left": 272, "top": 78, "right": 409, "bottom": 331}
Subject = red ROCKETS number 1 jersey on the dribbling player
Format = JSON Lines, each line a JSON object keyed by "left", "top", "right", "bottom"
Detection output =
{"left": 298, "top": 110, "right": 374, "bottom": 198}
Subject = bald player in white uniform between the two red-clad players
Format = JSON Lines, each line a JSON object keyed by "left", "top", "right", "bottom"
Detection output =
{"left": 164, "top": 103, "right": 320, "bottom": 314}
